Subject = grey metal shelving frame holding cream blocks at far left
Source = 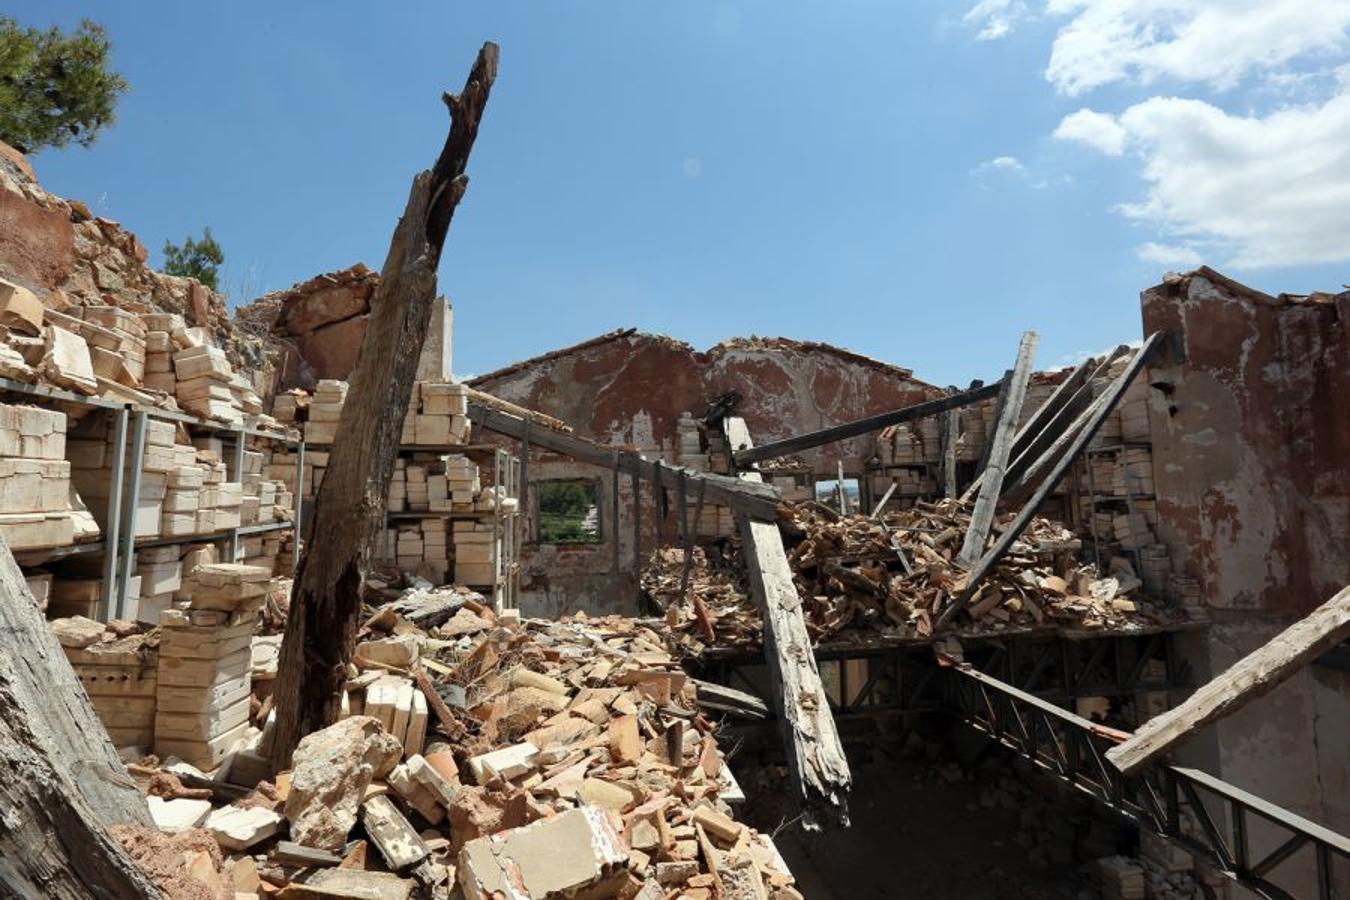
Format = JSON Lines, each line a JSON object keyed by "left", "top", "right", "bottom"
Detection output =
{"left": 0, "top": 378, "right": 305, "bottom": 619}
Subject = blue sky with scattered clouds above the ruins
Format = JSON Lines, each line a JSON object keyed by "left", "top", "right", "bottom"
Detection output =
{"left": 8, "top": 0, "right": 1350, "bottom": 385}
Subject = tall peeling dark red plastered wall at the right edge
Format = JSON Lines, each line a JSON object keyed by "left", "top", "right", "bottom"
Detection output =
{"left": 1142, "top": 270, "right": 1350, "bottom": 863}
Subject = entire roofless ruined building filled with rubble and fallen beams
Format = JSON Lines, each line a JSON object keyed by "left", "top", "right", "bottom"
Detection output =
{"left": 0, "top": 133, "right": 1350, "bottom": 900}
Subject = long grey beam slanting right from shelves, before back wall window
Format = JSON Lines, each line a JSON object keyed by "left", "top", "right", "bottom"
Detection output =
{"left": 468, "top": 391, "right": 780, "bottom": 522}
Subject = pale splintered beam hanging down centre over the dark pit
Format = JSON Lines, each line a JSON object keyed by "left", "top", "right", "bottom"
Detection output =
{"left": 722, "top": 416, "right": 853, "bottom": 830}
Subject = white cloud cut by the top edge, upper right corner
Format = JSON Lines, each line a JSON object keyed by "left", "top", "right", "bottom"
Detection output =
{"left": 1042, "top": 0, "right": 1350, "bottom": 96}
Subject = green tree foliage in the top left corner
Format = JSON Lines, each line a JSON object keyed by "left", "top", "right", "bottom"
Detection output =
{"left": 0, "top": 16, "right": 127, "bottom": 152}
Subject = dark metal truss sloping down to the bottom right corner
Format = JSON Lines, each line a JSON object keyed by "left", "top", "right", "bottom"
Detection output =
{"left": 941, "top": 665, "right": 1350, "bottom": 900}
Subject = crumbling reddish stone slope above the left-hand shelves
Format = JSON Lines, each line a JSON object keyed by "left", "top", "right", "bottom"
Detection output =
{"left": 0, "top": 143, "right": 278, "bottom": 394}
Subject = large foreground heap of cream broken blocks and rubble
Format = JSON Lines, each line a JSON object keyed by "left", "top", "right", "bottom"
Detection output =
{"left": 108, "top": 588, "right": 799, "bottom": 900}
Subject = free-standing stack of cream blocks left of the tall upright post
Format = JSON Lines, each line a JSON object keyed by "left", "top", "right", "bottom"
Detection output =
{"left": 155, "top": 563, "right": 271, "bottom": 769}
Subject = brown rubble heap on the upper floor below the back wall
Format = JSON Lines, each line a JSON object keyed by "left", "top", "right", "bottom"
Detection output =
{"left": 641, "top": 499, "right": 1176, "bottom": 652}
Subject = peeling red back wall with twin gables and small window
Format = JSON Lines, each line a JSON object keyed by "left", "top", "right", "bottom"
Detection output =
{"left": 473, "top": 331, "right": 936, "bottom": 615}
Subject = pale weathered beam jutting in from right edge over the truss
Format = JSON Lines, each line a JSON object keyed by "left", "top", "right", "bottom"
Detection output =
{"left": 1106, "top": 586, "right": 1350, "bottom": 773}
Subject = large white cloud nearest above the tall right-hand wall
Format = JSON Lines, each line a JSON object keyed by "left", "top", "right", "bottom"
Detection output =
{"left": 1118, "top": 90, "right": 1350, "bottom": 267}
